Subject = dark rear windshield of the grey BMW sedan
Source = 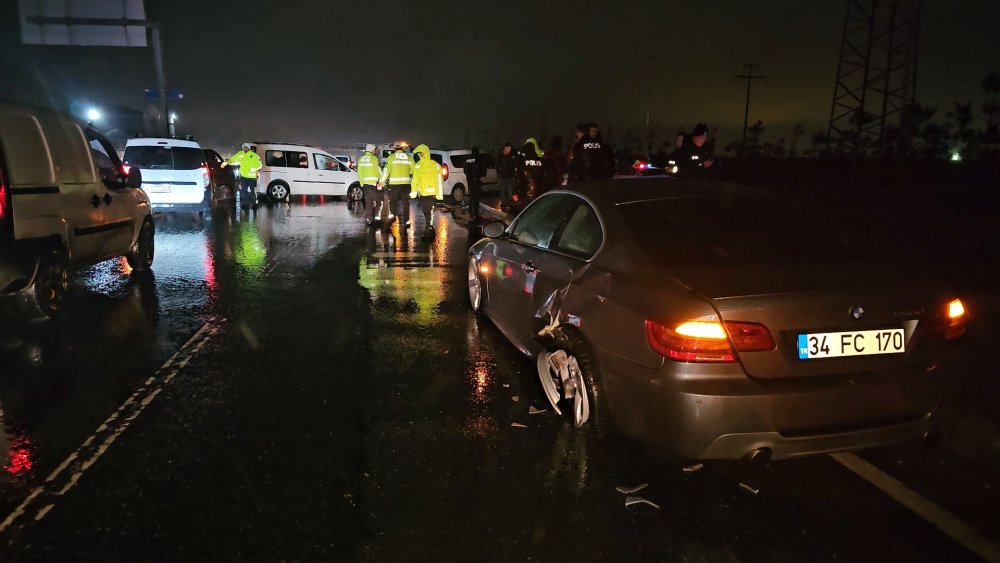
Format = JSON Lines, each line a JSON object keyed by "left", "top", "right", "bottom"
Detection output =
{"left": 619, "top": 195, "right": 863, "bottom": 268}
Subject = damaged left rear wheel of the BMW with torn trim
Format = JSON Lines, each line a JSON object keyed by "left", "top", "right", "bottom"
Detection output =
{"left": 538, "top": 330, "right": 612, "bottom": 437}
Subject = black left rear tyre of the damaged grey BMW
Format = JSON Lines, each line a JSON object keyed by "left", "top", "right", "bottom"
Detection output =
{"left": 539, "top": 328, "right": 614, "bottom": 439}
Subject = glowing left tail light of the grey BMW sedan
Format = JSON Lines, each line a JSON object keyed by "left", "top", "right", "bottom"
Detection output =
{"left": 646, "top": 320, "right": 775, "bottom": 363}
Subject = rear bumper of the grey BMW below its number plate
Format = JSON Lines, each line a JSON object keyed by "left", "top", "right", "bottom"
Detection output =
{"left": 601, "top": 357, "right": 936, "bottom": 459}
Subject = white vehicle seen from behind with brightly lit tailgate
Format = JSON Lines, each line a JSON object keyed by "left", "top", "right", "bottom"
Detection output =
{"left": 124, "top": 137, "right": 214, "bottom": 213}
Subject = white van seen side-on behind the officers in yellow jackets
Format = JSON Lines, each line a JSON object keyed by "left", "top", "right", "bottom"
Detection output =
{"left": 250, "top": 142, "right": 364, "bottom": 201}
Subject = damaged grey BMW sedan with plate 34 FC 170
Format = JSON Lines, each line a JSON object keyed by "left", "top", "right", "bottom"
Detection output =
{"left": 468, "top": 178, "right": 967, "bottom": 462}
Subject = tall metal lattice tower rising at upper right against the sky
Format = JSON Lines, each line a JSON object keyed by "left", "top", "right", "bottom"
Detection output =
{"left": 827, "top": 0, "right": 920, "bottom": 154}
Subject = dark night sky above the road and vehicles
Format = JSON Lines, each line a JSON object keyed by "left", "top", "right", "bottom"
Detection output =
{"left": 0, "top": 0, "right": 1000, "bottom": 154}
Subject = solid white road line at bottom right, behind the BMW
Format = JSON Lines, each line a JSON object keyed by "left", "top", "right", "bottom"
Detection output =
{"left": 830, "top": 452, "right": 1000, "bottom": 563}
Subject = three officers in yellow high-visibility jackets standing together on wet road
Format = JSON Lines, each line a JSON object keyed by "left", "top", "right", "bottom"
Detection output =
{"left": 358, "top": 142, "right": 444, "bottom": 238}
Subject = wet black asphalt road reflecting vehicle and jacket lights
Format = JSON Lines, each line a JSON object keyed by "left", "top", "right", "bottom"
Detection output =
{"left": 0, "top": 201, "right": 1000, "bottom": 561}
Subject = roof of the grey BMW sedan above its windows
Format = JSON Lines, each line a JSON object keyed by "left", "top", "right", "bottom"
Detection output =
{"left": 566, "top": 178, "right": 767, "bottom": 207}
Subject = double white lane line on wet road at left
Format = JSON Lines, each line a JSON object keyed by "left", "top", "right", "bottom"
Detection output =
{"left": 0, "top": 318, "right": 222, "bottom": 533}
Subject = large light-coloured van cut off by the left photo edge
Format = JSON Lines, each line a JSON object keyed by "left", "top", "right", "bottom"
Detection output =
{"left": 0, "top": 102, "right": 154, "bottom": 316}
